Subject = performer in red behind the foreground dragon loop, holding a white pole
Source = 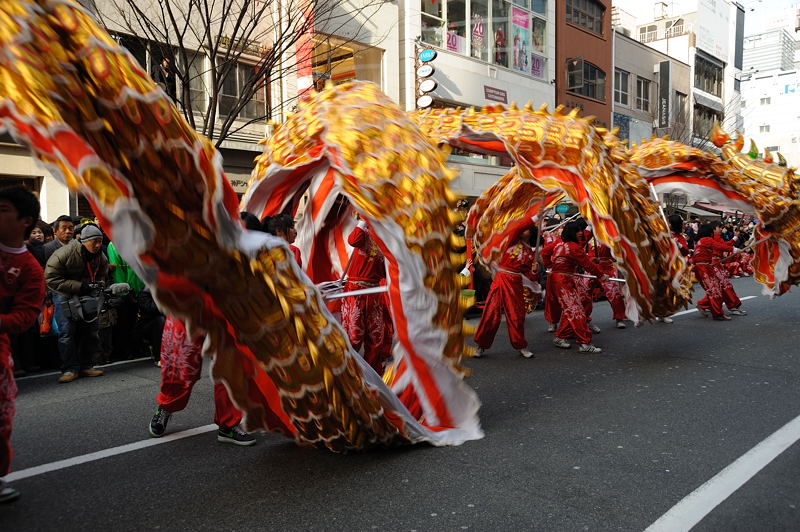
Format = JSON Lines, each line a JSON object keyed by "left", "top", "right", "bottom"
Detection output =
{"left": 342, "top": 214, "right": 394, "bottom": 375}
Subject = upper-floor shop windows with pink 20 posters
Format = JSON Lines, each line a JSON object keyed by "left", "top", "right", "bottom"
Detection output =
{"left": 420, "top": 0, "right": 547, "bottom": 79}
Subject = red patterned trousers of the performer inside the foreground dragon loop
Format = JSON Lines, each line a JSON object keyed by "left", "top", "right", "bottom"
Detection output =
{"left": 342, "top": 281, "right": 394, "bottom": 375}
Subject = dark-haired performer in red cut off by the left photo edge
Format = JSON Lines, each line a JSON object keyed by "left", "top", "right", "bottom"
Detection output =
{"left": 0, "top": 187, "right": 44, "bottom": 503}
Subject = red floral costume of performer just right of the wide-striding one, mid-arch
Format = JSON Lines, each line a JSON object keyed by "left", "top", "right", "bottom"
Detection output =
{"left": 550, "top": 242, "right": 603, "bottom": 344}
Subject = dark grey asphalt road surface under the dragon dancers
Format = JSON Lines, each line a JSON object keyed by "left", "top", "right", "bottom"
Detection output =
{"left": 0, "top": 279, "right": 800, "bottom": 531}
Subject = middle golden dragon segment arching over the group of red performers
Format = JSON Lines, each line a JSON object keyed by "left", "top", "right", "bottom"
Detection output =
{"left": 412, "top": 105, "right": 691, "bottom": 319}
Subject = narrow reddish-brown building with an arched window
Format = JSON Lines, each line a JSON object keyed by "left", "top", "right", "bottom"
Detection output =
{"left": 555, "top": 0, "right": 614, "bottom": 127}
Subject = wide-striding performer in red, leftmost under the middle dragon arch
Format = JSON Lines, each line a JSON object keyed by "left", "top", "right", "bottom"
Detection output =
{"left": 475, "top": 228, "right": 538, "bottom": 358}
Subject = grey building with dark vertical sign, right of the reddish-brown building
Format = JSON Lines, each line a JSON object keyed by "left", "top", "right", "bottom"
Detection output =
{"left": 614, "top": 32, "right": 692, "bottom": 144}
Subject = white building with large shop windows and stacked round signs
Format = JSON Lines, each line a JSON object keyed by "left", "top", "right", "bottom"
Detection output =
{"left": 406, "top": 0, "right": 557, "bottom": 196}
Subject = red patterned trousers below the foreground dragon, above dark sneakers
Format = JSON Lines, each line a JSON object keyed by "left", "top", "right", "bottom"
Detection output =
{"left": 156, "top": 317, "right": 242, "bottom": 428}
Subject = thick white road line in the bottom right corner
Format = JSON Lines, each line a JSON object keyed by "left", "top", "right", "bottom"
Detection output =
{"left": 645, "top": 416, "right": 800, "bottom": 532}
